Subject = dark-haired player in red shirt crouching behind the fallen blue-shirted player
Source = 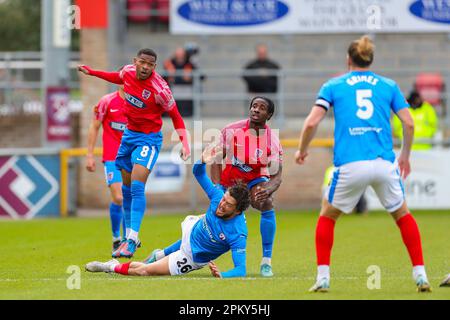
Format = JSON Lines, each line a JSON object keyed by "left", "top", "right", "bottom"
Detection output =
{"left": 211, "top": 96, "right": 283, "bottom": 277}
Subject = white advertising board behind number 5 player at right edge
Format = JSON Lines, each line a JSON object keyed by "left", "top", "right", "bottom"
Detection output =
{"left": 366, "top": 149, "right": 450, "bottom": 210}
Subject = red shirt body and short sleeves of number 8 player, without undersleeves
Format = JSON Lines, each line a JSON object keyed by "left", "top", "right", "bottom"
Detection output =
{"left": 119, "top": 65, "right": 175, "bottom": 133}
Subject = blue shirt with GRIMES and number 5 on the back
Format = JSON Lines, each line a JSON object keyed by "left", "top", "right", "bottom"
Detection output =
{"left": 315, "top": 71, "right": 409, "bottom": 167}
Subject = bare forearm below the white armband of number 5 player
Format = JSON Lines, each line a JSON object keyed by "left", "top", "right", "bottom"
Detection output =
{"left": 295, "top": 105, "right": 327, "bottom": 164}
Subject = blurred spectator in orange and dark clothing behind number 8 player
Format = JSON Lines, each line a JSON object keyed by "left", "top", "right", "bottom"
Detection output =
{"left": 164, "top": 47, "right": 196, "bottom": 117}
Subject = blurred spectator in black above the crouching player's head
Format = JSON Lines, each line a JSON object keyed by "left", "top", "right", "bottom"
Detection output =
{"left": 243, "top": 44, "right": 280, "bottom": 94}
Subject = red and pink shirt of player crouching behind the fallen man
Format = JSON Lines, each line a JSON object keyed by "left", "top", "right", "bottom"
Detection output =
{"left": 220, "top": 120, "right": 283, "bottom": 187}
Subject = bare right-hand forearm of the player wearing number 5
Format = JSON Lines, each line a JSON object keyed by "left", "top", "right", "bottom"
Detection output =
{"left": 397, "top": 108, "right": 414, "bottom": 179}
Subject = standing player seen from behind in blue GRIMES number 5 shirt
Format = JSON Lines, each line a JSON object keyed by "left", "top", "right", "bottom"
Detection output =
{"left": 295, "top": 36, "right": 431, "bottom": 292}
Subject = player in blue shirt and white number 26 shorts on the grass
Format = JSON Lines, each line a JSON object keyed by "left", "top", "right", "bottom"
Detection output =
{"left": 86, "top": 146, "right": 250, "bottom": 278}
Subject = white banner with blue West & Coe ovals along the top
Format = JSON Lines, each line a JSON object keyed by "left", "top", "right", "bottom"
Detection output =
{"left": 170, "top": 0, "right": 450, "bottom": 34}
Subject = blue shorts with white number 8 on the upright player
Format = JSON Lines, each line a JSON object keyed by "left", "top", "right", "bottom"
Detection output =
{"left": 116, "top": 129, "right": 163, "bottom": 172}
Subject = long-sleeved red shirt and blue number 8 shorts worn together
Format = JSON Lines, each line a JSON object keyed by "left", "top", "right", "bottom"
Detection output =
{"left": 84, "top": 65, "right": 189, "bottom": 172}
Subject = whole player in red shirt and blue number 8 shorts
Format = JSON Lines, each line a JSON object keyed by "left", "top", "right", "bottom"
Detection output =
{"left": 78, "top": 49, "right": 190, "bottom": 258}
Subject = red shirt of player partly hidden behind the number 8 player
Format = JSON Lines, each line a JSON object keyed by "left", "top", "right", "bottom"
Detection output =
{"left": 94, "top": 91, "right": 127, "bottom": 161}
